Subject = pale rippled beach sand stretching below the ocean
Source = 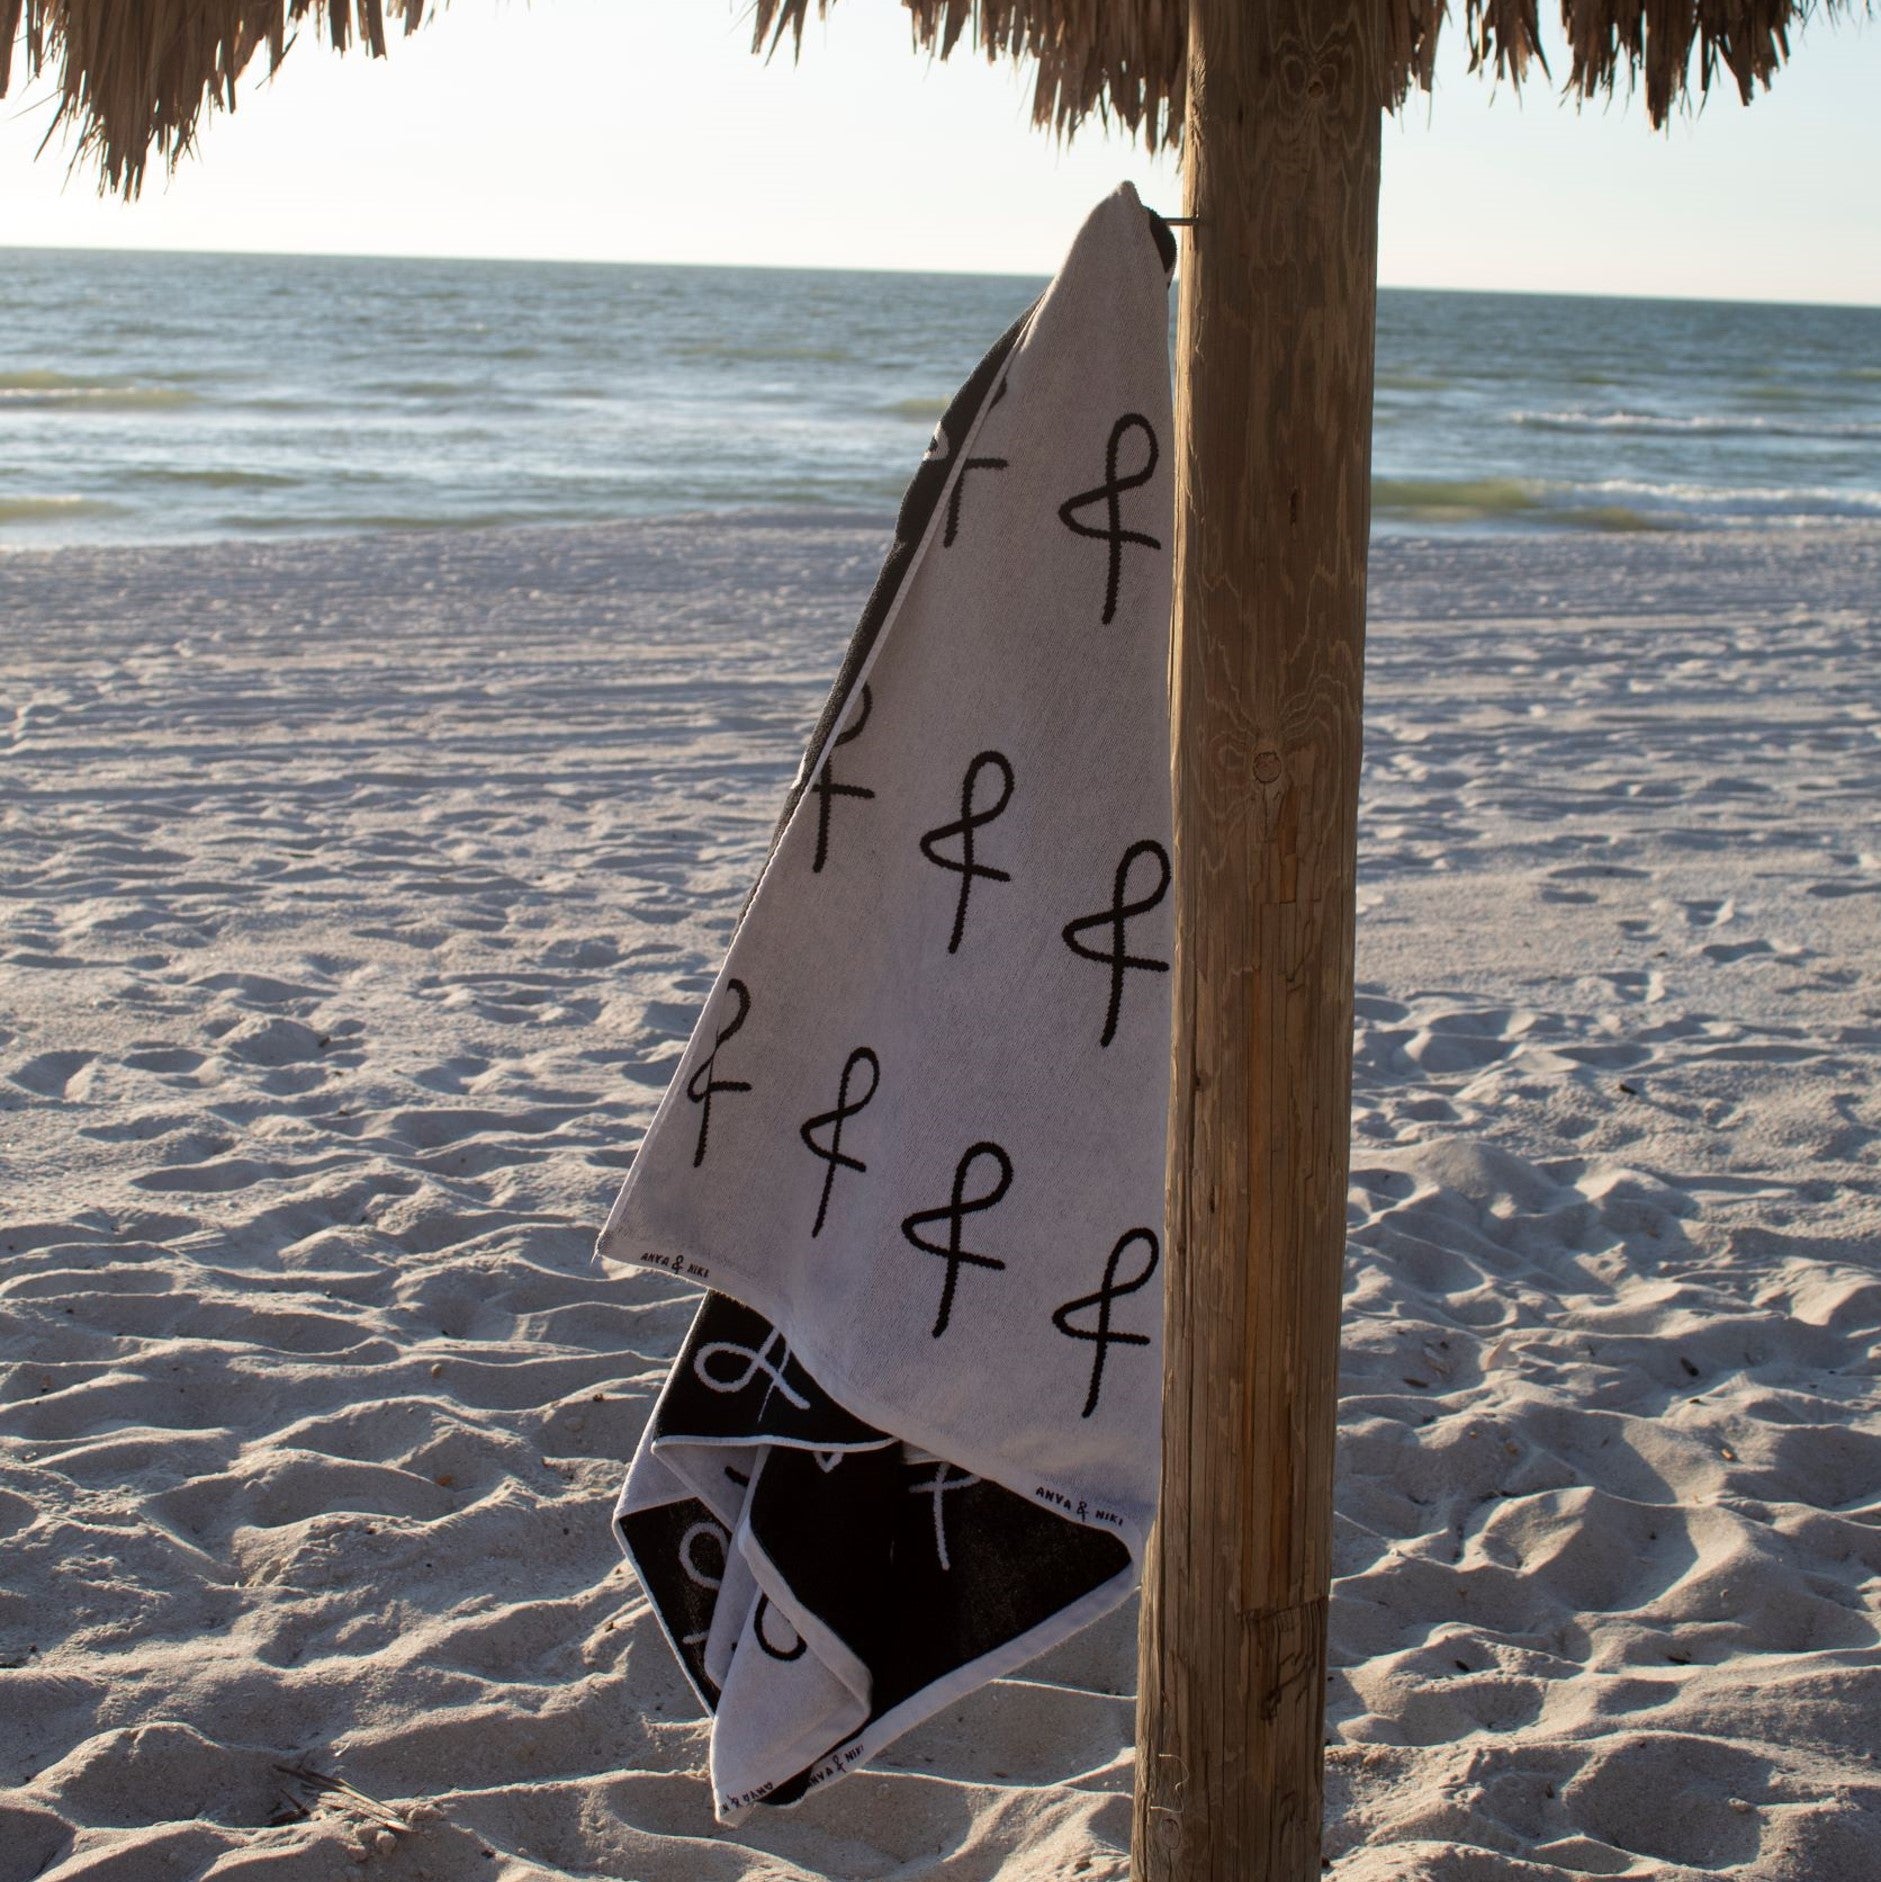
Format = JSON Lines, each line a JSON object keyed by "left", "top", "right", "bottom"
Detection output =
{"left": 0, "top": 518, "right": 1881, "bottom": 1882}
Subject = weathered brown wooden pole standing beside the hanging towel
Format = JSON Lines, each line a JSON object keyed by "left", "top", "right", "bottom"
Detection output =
{"left": 1133, "top": 0, "right": 1384, "bottom": 1882}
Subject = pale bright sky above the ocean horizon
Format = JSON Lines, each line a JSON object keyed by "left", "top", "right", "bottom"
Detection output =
{"left": 0, "top": 0, "right": 1881, "bottom": 305}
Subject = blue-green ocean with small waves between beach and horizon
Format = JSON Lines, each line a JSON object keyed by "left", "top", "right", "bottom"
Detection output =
{"left": 0, "top": 248, "right": 1881, "bottom": 550}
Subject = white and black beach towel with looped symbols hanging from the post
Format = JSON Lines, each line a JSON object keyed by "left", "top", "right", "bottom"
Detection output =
{"left": 601, "top": 186, "right": 1175, "bottom": 1824}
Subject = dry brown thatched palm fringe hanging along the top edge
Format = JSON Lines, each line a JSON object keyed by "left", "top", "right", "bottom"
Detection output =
{"left": 0, "top": 0, "right": 1851, "bottom": 194}
